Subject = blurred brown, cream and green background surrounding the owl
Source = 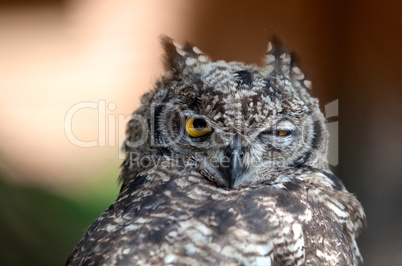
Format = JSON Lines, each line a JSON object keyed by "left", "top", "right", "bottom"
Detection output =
{"left": 0, "top": 0, "right": 402, "bottom": 265}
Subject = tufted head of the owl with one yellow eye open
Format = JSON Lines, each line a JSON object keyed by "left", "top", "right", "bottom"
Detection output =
{"left": 125, "top": 37, "right": 328, "bottom": 189}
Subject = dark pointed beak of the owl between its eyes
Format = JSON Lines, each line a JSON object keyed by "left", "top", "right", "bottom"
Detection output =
{"left": 219, "top": 134, "right": 245, "bottom": 188}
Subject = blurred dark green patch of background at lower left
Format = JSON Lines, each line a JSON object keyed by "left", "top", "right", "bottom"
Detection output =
{"left": 0, "top": 170, "right": 119, "bottom": 265}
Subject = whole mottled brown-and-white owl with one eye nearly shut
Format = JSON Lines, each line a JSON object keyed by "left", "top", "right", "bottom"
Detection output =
{"left": 67, "top": 37, "right": 366, "bottom": 265}
